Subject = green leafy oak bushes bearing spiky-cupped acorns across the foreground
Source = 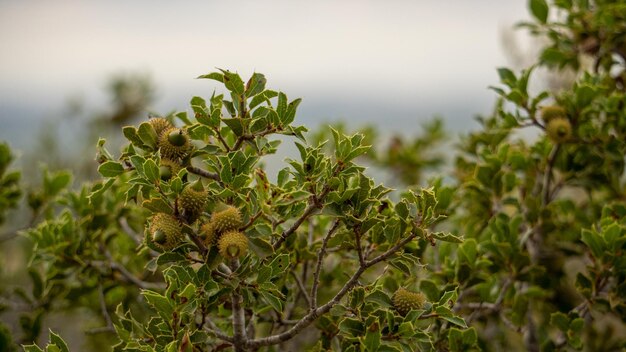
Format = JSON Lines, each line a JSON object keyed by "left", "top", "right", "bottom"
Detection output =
{"left": 0, "top": 0, "right": 626, "bottom": 352}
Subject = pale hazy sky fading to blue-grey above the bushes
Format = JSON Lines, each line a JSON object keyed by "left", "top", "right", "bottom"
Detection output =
{"left": 0, "top": 0, "right": 528, "bottom": 148}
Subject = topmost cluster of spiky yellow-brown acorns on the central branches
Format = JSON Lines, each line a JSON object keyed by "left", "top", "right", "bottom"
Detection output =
{"left": 149, "top": 117, "right": 193, "bottom": 180}
